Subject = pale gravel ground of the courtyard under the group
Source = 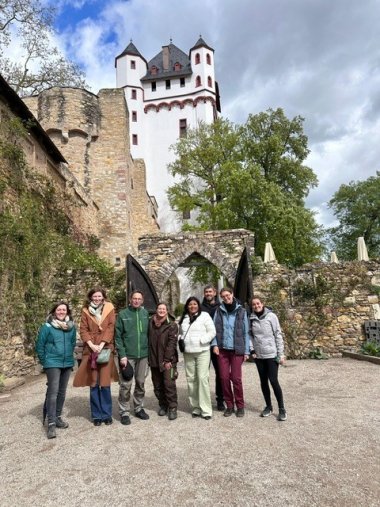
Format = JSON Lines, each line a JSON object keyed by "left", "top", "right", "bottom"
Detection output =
{"left": 0, "top": 359, "right": 380, "bottom": 507}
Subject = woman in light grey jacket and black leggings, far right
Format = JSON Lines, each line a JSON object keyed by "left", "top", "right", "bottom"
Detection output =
{"left": 250, "top": 296, "right": 287, "bottom": 421}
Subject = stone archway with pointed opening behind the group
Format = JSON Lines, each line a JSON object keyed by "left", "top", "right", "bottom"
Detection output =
{"left": 138, "top": 229, "right": 254, "bottom": 296}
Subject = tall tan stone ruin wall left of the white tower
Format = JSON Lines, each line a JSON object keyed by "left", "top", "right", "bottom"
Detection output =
{"left": 25, "top": 88, "right": 158, "bottom": 265}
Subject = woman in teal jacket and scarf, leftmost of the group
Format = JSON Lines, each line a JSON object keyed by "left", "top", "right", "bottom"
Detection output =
{"left": 36, "top": 302, "right": 76, "bottom": 438}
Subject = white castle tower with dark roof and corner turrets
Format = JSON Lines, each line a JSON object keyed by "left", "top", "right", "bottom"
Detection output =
{"left": 115, "top": 37, "right": 220, "bottom": 232}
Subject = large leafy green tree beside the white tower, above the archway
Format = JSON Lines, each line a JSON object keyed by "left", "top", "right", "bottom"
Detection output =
{"left": 168, "top": 109, "right": 322, "bottom": 266}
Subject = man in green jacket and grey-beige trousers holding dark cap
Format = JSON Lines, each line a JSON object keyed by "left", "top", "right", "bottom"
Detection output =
{"left": 115, "top": 290, "right": 149, "bottom": 424}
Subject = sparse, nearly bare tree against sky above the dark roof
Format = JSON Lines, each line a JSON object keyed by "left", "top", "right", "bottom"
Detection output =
{"left": 0, "top": 0, "right": 86, "bottom": 96}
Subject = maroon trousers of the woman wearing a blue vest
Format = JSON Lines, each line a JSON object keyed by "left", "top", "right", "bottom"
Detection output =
{"left": 218, "top": 349, "right": 244, "bottom": 408}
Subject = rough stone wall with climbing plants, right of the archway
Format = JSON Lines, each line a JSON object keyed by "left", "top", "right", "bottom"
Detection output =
{"left": 253, "top": 259, "right": 380, "bottom": 358}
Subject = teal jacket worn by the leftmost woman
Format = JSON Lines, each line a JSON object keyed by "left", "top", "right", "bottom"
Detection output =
{"left": 36, "top": 322, "right": 77, "bottom": 369}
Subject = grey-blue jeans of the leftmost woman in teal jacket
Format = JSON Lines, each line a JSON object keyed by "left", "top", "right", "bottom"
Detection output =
{"left": 45, "top": 368, "right": 72, "bottom": 423}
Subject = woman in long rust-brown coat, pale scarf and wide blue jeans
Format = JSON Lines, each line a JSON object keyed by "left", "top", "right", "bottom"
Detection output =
{"left": 74, "top": 287, "right": 118, "bottom": 426}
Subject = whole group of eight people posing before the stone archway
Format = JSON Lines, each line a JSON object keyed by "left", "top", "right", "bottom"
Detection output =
{"left": 36, "top": 285, "right": 287, "bottom": 438}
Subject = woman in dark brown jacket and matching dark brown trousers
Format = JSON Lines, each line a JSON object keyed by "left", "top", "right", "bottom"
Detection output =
{"left": 148, "top": 303, "right": 178, "bottom": 421}
